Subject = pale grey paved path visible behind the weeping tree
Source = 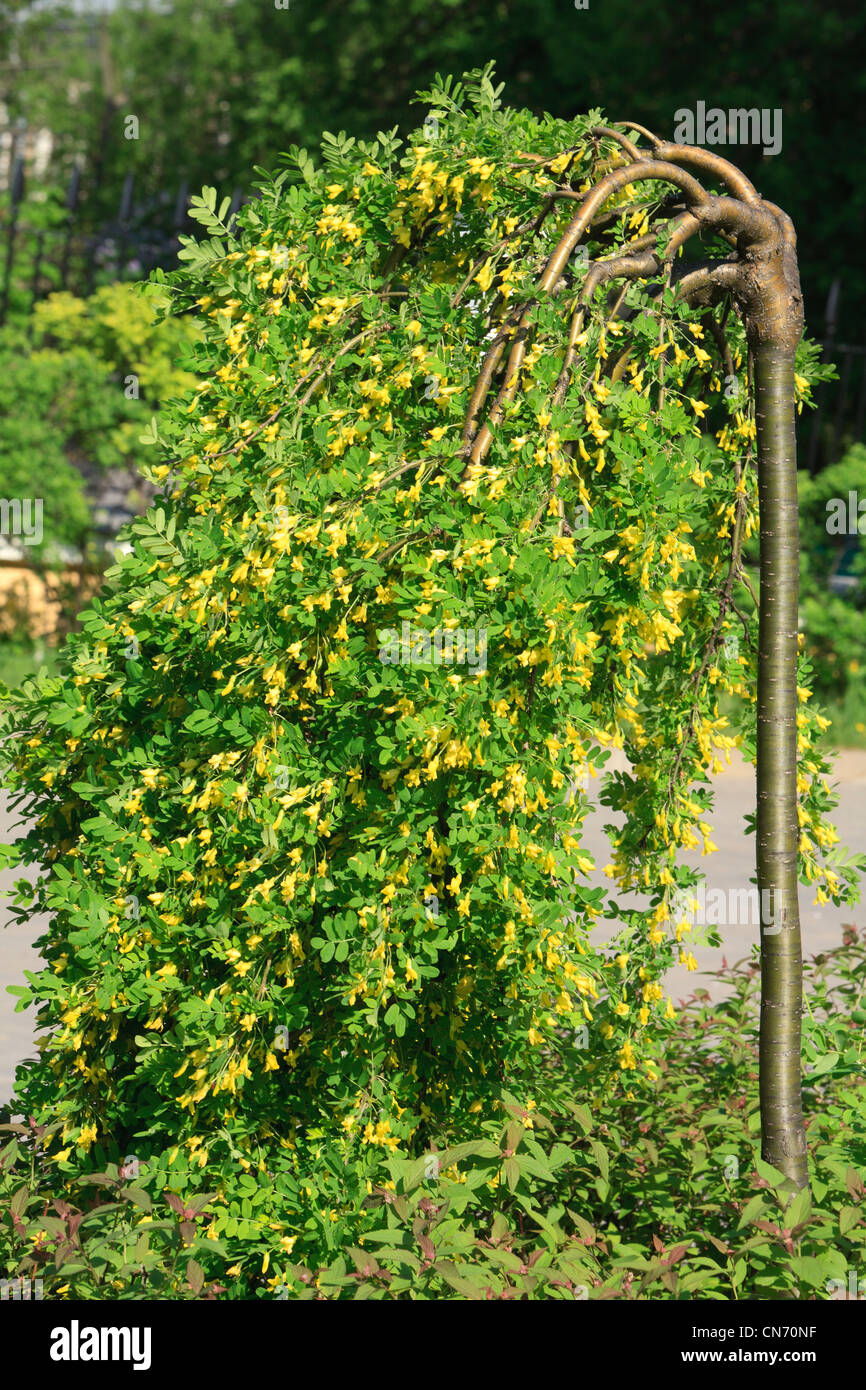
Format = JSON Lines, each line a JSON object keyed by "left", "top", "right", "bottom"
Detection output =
{"left": 0, "top": 749, "right": 866, "bottom": 1102}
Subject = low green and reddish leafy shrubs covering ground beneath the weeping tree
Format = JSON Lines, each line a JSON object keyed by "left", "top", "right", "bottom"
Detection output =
{"left": 0, "top": 929, "right": 866, "bottom": 1300}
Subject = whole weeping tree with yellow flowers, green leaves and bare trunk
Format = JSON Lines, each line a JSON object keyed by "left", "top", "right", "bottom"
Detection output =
{"left": 3, "top": 71, "right": 851, "bottom": 1269}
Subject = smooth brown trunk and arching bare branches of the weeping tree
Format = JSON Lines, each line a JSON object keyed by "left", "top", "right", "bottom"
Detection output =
{"left": 464, "top": 116, "right": 806, "bottom": 1187}
